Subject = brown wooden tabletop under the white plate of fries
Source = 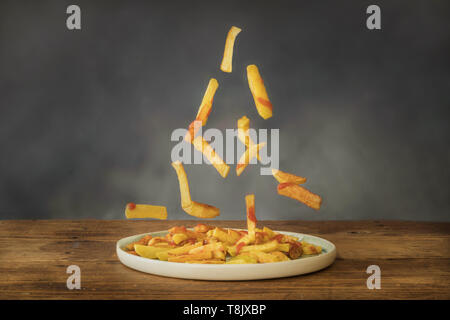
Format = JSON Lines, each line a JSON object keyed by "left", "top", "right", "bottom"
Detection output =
{"left": 0, "top": 220, "right": 450, "bottom": 299}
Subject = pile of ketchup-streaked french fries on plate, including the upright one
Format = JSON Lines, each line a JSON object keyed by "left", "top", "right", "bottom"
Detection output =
{"left": 123, "top": 194, "right": 322, "bottom": 264}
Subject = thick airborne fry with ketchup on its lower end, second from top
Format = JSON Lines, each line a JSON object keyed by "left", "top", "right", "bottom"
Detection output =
{"left": 247, "top": 64, "right": 272, "bottom": 120}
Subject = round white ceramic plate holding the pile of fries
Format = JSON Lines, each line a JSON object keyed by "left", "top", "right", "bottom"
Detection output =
{"left": 116, "top": 231, "right": 336, "bottom": 280}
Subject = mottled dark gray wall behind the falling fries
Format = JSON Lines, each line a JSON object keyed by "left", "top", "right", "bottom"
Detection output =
{"left": 0, "top": 0, "right": 450, "bottom": 221}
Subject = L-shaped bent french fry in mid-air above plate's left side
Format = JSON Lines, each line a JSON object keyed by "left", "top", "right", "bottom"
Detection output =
{"left": 172, "top": 161, "right": 220, "bottom": 219}
